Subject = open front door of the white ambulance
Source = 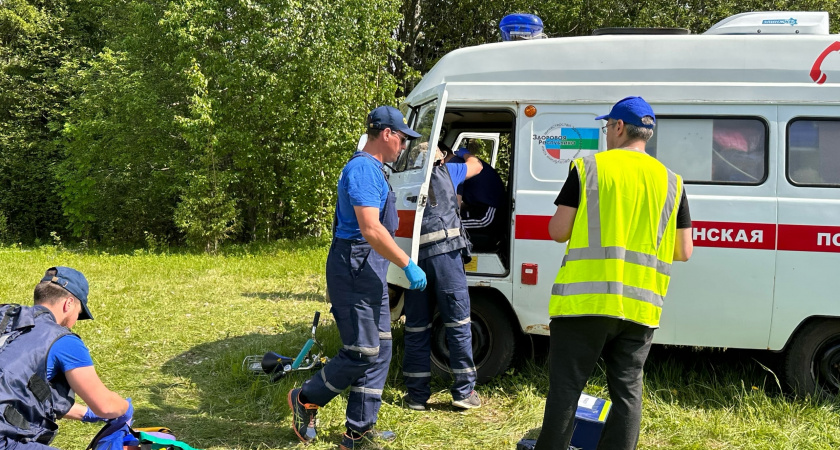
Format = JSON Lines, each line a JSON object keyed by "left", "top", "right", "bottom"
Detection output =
{"left": 388, "top": 84, "right": 447, "bottom": 288}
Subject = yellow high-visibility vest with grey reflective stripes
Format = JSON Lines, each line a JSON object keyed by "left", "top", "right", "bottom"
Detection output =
{"left": 548, "top": 150, "right": 683, "bottom": 328}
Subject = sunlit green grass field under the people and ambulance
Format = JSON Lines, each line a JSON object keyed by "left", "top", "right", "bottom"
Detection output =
{"left": 0, "top": 240, "right": 840, "bottom": 450}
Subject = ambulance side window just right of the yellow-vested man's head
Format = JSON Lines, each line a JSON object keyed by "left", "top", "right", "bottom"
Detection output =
{"left": 647, "top": 117, "right": 767, "bottom": 184}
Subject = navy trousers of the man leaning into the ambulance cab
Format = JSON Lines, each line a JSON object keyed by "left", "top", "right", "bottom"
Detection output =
{"left": 403, "top": 249, "right": 476, "bottom": 403}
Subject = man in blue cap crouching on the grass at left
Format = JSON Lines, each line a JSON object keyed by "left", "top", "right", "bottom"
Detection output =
{"left": 0, "top": 266, "right": 134, "bottom": 450}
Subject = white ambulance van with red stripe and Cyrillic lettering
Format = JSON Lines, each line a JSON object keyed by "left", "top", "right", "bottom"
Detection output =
{"left": 389, "top": 12, "right": 840, "bottom": 392}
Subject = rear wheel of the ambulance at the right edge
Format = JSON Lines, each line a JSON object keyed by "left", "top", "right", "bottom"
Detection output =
{"left": 785, "top": 319, "right": 840, "bottom": 397}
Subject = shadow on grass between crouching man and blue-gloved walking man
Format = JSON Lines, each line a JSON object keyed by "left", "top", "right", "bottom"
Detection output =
{"left": 154, "top": 323, "right": 331, "bottom": 449}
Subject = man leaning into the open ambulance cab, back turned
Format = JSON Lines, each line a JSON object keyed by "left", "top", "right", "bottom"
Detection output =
{"left": 403, "top": 144, "right": 482, "bottom": 411}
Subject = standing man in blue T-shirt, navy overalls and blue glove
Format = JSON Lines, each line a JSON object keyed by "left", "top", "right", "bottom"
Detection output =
{"left": 288, "top": 106, "right": 426, "bottom": 449}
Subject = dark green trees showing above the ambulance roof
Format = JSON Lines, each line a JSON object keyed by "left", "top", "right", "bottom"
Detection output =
{"left": 392, "top": 0, "right": 840, "bottom": 95}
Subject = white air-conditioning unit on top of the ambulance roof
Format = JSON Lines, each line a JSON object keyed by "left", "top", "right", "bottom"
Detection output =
{"left": 703, "top": 11, "right": 828, "bottom": 34}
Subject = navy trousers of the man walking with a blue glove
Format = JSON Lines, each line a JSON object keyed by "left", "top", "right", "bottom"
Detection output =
{"left": 301, "top": 238, "right": 391, "bottom": 433}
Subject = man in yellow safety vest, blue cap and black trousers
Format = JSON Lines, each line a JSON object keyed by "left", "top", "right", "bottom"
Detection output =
{"left": 536, "top": 97, "right": 693, "bottom": 450}
